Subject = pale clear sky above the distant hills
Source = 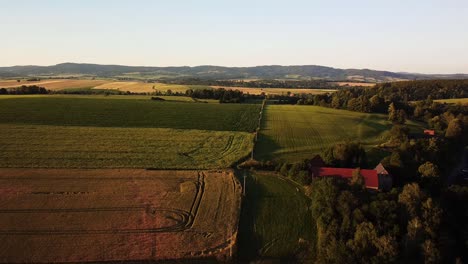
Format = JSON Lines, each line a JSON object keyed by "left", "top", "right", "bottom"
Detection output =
{"left": 0, "top": 0, "right": 468, "bottom": 73}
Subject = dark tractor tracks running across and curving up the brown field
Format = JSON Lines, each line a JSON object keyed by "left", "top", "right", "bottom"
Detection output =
{"left": 0, "top": 171, "right": 205, "bottom": 235}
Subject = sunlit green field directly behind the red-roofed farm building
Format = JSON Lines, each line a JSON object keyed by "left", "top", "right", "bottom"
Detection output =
{"left": 255, "top": 105, "right": 423, "bottom": 161}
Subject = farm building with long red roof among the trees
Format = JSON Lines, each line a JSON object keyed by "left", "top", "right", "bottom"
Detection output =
{"left": 309, "top": 155, "right": 393, "bottom": 190}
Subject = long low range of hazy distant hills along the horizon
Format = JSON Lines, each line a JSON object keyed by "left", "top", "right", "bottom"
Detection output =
{"left": 0, "top": 63, "right": 468, "bottom": 82}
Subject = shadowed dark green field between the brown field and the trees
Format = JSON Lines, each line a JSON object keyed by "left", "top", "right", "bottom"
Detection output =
{"left": 239, "top": 171, "right": 312, "bottom": 263}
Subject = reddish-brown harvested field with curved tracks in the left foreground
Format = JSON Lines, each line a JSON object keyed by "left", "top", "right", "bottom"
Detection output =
{"left": 0, "top": 169, "right": 241, "bottom": 263}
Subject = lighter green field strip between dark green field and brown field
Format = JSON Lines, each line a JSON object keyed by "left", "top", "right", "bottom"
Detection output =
{"left": 0, "top": 124, "right": 253, "bottom": 169}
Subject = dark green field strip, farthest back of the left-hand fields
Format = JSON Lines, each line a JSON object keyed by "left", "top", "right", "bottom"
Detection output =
{"left": 0, "top": 95, "right": 260, "bottom": 132}
